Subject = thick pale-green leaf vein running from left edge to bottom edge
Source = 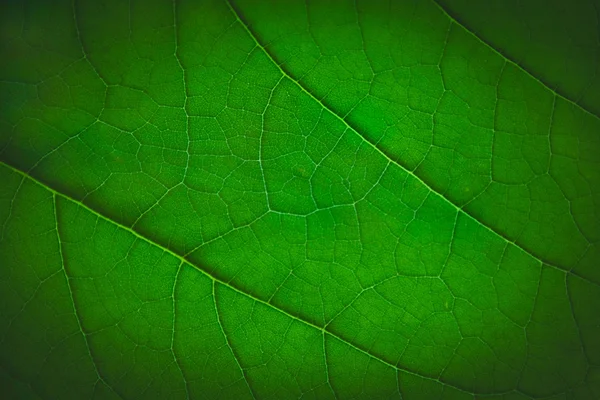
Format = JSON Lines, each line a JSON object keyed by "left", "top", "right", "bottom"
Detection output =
{"left": 0, "top": 161, "right": 494, "bottom": 395}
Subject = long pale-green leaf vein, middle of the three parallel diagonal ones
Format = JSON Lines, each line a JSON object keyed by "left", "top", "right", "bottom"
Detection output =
{"left": 226, "top": 0, "right": 600, "bottom": 286}
